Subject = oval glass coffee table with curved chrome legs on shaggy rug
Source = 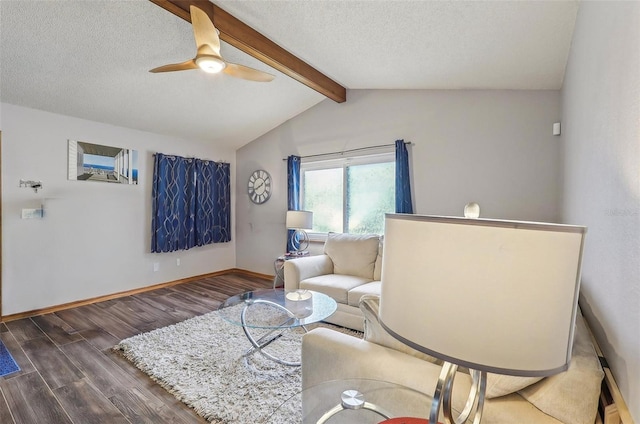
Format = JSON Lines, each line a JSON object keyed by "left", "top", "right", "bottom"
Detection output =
{"left": 218, "top": 289, "right": 338, "bottom": 367}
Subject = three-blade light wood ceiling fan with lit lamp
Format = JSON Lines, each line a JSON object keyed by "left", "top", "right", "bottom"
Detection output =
{"left": 149, "top": 6, "right": 275, "bottom": 82}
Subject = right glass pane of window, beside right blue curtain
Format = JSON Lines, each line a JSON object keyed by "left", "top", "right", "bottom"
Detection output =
{"left": 345, "top": 162, "right": 395, "bottom": 234}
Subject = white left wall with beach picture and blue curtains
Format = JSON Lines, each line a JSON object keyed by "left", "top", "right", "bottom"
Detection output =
{"left": 0, "top": 104, "right": 235, "bottom": 315}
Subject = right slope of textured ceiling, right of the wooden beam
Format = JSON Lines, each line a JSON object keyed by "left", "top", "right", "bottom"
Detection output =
{"left": 214, "top": 1, "right": 578, "bottom": 89}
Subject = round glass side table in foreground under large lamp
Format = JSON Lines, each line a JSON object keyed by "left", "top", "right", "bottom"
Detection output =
{"left": 265, "top": 379, "right": 444, "bottom": 424}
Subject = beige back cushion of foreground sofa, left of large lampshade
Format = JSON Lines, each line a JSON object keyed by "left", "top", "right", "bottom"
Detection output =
{"left": 360, "top": 295, "right": 442, "bottom": 364}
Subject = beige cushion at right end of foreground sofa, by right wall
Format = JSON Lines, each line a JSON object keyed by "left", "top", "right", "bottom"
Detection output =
{"left": 518, "top": 313, "right": 604, "bottom": 424}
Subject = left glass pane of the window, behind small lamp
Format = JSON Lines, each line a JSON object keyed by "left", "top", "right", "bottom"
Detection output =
{"left": 302, "top": 168, "right": 342, "bottom": 233}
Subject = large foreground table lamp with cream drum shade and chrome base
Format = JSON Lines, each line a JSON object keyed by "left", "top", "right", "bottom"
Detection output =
{"left": 379, "top": 214, "right": 586, "bottom": 424}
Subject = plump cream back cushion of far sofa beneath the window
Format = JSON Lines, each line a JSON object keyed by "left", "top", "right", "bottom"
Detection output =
{"left": 324, "top": 233, "right": 380, "bottom": 281}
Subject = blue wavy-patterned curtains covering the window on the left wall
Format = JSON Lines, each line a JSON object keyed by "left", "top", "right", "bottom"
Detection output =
{"left": 151, "top": 153, "right": 230, "bottom": 253}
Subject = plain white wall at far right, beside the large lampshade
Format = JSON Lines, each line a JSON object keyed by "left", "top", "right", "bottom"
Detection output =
{"left": 562, "top": 2, "right": 640, "bottom": 422}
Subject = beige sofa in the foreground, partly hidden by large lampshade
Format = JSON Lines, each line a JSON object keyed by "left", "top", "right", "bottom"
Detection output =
{"left": 302, "top": 296, "right": 604, "bottom": 424}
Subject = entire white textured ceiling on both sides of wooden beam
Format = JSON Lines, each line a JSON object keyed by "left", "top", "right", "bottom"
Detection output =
{"left": 0, "top": 0, "right": 578, "bottom": 148}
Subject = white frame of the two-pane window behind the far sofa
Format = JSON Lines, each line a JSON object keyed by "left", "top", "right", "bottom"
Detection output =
{"left": 300, "top": 148, "right": 396, "bottom": 242}
